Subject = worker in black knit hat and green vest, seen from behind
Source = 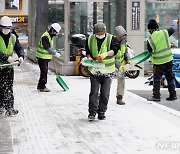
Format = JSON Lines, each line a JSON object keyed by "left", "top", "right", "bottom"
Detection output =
{"left": 147, "top": 19, "right": 177, "bottom": 102}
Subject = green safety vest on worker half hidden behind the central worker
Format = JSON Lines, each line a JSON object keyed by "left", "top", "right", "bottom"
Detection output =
{"left": 115, "top": 41, "right": 127, "bottom": 65}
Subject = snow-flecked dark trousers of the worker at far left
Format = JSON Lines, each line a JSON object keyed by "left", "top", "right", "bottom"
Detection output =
{"left": 0, "top": 68, "right": 14, "bottom": 109}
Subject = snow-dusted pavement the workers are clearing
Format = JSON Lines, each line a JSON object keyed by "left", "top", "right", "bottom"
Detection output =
{"left": 0, "top": 60, "right": 180, "bottom": 154}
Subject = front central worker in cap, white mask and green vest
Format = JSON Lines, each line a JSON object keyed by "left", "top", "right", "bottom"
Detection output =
{"left": 86, "top": 23, "right": 119, "bottom": 121}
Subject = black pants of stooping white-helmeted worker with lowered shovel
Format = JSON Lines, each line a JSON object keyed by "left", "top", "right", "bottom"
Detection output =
{"left": 37, "top": 58, "right": 50, "bottom": 89}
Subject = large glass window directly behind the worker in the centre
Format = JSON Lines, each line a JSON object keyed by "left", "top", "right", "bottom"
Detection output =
{"left": 70, "top": 2, "right": 116, "bottom": 61}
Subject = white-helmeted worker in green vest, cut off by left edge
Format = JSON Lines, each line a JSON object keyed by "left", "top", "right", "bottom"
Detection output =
{"left": 0, "top": 16, "right": 24, "bottom": 116}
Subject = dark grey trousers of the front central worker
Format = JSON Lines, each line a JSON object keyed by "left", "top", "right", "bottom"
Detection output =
{"left": 89, "top": 75, "right": 112, "bottom": 113}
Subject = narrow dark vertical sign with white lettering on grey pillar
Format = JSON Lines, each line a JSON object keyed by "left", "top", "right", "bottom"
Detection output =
{"left": 132, "top": 1, "right": 140, "bottom": 30}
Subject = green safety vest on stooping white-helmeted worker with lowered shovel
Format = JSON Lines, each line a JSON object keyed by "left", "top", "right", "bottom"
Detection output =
{"left": 36, "top": 31, "right": 53, "bottom": 59}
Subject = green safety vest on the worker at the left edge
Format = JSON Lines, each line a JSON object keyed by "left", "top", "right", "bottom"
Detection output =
{"left": 0, "top": 34, "right": 16, "bottom": 64}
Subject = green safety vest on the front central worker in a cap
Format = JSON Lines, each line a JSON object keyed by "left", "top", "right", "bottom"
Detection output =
{"left": 88, "top": 33, "right": 115, "bottom": 73}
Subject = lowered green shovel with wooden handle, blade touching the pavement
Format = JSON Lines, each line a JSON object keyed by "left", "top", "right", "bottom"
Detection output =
{"left": 53, "top": 57, "right": 69, "bottom": 91}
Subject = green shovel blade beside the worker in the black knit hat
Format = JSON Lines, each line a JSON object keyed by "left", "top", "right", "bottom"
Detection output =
{"left": 130, "top": 50, "right": 151, "bottom": 64}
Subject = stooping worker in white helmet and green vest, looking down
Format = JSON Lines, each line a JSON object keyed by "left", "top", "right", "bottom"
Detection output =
{"left": 36, "top": 23, "right": 61, "bottom": 92}
